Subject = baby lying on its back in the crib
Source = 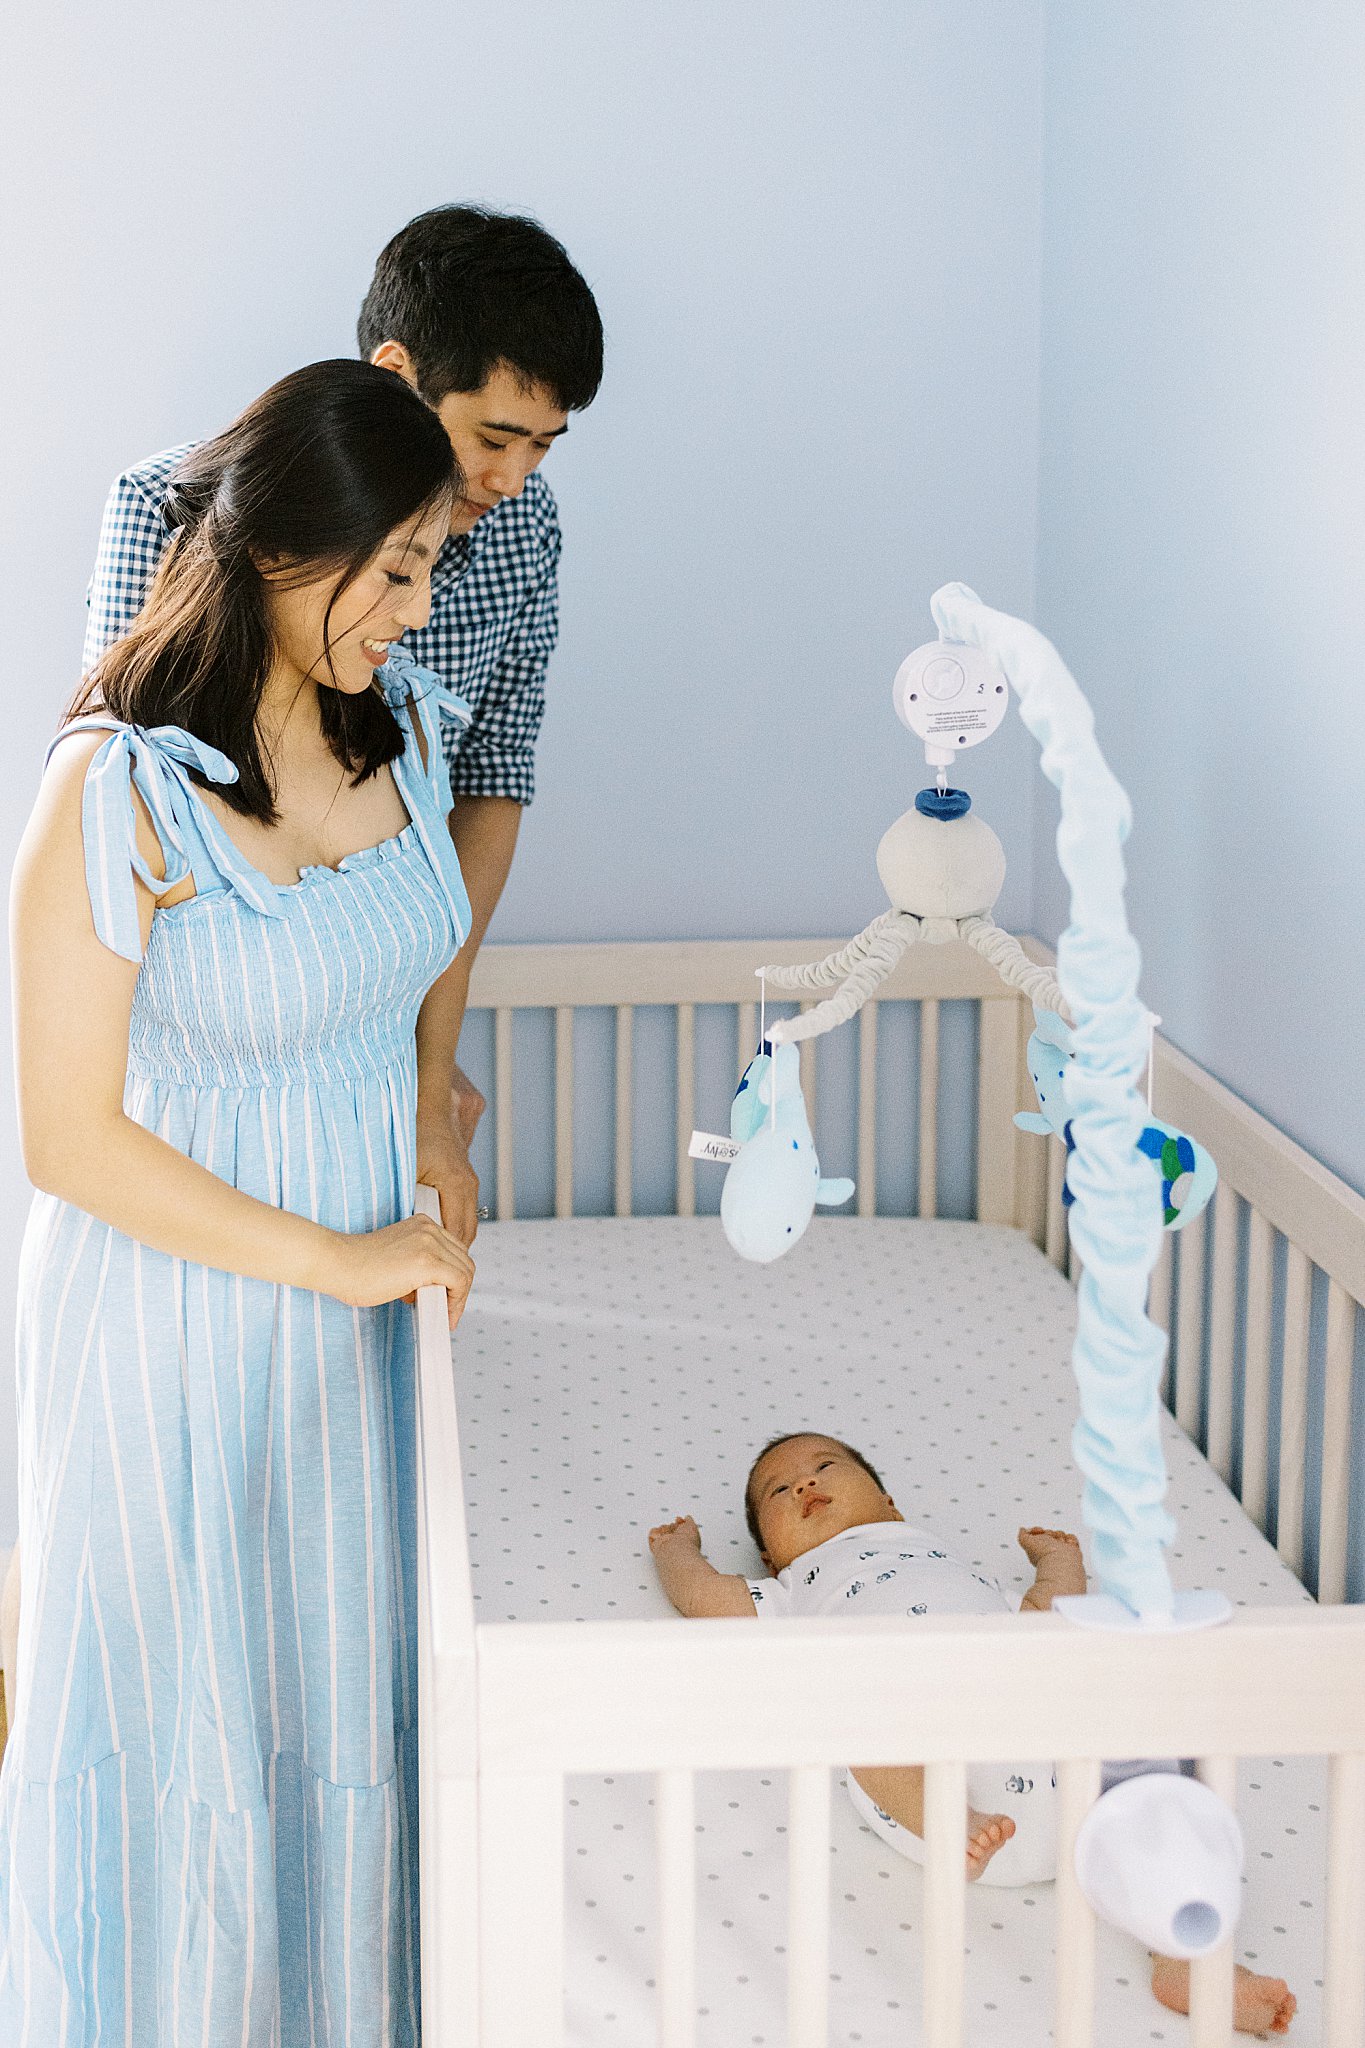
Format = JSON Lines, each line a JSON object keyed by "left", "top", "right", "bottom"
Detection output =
{"left": 649, "top": 1434, "right": 1295, "bottom": 2034}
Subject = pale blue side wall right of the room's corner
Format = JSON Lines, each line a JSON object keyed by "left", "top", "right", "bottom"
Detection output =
{"left": 1036, "top": 0, "right": 1365, "bottom": 1190}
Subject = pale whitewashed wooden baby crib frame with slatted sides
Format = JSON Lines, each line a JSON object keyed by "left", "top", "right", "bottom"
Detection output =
{"left": 417, "top": 940, "right": 1365, "bottom": 2048}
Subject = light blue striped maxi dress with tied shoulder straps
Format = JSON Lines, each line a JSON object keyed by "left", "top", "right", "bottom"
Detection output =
{"left": 0, "top": 662, "right": 469, "bottom": 2048}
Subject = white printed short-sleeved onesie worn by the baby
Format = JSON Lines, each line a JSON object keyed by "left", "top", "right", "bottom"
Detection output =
{"left": 745, "top": 1522, "right": 1056, "bottom": 1884}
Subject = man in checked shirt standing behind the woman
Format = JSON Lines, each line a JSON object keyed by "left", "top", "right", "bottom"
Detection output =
{"left": 82, "top": 207, "right": 602, "bottom": 1241}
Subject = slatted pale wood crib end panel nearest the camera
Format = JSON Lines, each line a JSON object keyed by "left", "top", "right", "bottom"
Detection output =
{"left": 464, "top": 1608, "right": 1365, "bottom": 2048}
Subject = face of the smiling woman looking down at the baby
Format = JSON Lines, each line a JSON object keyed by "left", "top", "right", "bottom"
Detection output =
{"left": 264, "top": 498, "right": 450, "bottom": 696}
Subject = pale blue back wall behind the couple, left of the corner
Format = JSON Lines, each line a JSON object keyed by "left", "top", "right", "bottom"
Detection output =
{"left": 0, "top": 0, "right": 1042, "bottom": 1542}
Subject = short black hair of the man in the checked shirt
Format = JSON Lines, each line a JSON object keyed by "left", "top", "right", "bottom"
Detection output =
{"left": 356, "top": 207, "right": 602, "bottom": 412}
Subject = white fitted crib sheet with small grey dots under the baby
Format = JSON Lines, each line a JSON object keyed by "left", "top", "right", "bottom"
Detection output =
{"left": 456, "top": 1217, "right": 1326, "bottom": 2048}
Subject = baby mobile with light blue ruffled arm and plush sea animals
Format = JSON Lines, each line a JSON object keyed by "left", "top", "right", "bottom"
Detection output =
{"left": 694, "top": 584, "right": 1242, "bottom": 1956}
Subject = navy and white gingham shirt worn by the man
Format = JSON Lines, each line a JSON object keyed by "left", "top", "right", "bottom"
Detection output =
{"left": 82, "top": 446, "right": 561, "bottom": 803}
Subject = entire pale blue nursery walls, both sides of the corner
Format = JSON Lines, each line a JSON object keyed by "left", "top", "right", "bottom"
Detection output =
{"left": 0, "top": 0, "right": 1365, "bottom": 1542}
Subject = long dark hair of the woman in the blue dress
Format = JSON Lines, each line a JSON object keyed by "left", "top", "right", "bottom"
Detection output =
{"left": 68, "top": 360, "right": 460, "bottom": 823}
